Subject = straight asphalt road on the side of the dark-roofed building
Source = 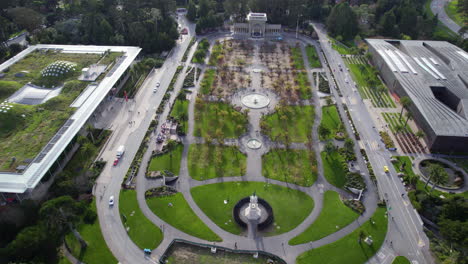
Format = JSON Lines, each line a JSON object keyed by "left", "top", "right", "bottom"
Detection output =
{"left": 314, "top": 24, "right": 434, "bottom": 264}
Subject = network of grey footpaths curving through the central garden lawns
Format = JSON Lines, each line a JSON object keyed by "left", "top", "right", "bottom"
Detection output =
{"left": 132, "top": 35, "right": 384, "bottom": 263}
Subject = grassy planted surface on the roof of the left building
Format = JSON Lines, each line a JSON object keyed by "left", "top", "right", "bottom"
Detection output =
{"left": 0, "top": 51, "right": 122, "bottom": 171}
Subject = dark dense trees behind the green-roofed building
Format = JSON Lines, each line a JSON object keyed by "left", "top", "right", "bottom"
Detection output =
{"left": 0, "top": 0, "right": 179, "bottom": 53}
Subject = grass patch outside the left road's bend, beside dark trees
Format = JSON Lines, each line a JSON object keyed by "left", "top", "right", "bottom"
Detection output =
{"left": 65, "top": 201, "right": 117, "bottom": 264}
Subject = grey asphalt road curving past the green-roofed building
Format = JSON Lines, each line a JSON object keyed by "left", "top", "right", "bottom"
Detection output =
{"left": 94, "top": 14, "right": 195, "bottom": 263}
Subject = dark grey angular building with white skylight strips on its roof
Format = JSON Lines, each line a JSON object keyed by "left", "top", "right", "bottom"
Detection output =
{"left": 366, "top": 39, "right": 468, "bottom": 152}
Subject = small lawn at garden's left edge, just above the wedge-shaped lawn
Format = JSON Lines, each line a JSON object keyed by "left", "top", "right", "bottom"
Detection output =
{"left": 148, "top": 144, "right": 184, "bottom": 175}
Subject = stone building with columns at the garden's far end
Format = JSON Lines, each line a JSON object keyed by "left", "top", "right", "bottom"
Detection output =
{"left": 231, "top": 13, "right": 281, "bottom": 38}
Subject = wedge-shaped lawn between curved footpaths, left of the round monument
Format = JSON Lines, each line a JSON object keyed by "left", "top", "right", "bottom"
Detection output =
{"left": 146, "top": 193, "right": 222, "bottom": 242}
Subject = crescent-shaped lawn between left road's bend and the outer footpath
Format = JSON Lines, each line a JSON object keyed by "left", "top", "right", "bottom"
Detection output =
{"left": 119, "top": 190, "right": 163, "bottom": 249}
